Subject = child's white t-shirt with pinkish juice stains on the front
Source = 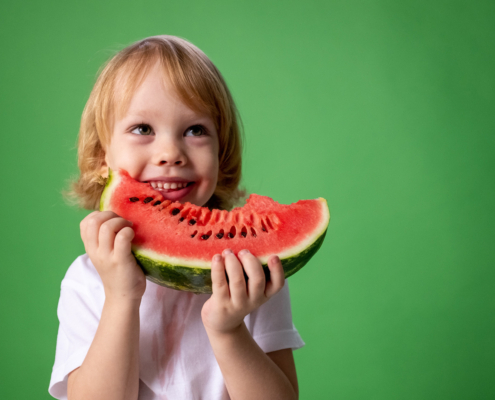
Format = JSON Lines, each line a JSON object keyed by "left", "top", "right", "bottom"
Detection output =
{"left": 49, "top": 255, "right": 304, "bottom": 400}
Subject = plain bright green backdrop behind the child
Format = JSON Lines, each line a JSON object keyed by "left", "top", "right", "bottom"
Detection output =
{"left": 0, "top": 0, "right": 495, "bottom": 399}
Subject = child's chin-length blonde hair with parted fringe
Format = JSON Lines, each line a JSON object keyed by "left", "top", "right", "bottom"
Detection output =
{"left": 68, "top": 35, "right": 244, "bottom": 209}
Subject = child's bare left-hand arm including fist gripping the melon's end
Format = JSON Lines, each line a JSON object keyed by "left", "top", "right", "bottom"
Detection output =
{"left": 68, "top": 212, "right": 146, "bottom": 400}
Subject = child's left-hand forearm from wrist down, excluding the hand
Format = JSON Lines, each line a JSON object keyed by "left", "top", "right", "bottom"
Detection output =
{"left": 68, "top": 299, "right": 140, "bottom": 400}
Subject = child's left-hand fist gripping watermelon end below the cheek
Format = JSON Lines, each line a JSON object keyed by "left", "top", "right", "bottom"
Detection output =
{"left": 81, "top": 211, "right": 146, "bottom": 300}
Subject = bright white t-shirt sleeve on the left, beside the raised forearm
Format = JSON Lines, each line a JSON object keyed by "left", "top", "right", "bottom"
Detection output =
{"left": 48, "top": 255, "right": 104, "bottom": 399}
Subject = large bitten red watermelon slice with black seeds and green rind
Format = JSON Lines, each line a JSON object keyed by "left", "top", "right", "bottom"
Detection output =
{"left": 100, "top": 170, "right": 330, "bottom": 293}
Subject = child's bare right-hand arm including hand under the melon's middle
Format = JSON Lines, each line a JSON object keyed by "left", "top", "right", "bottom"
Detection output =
{"left": 202, "top": 250, "right": 298, "bottom": 400}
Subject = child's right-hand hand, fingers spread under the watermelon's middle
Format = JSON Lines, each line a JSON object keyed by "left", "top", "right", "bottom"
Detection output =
{"left": 201, "top": 249, "right": 285, "bottom": 333}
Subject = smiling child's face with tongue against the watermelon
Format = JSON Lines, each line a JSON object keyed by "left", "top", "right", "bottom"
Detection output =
{"left": 105, "top": 65, "right": 218, "bottom": 206}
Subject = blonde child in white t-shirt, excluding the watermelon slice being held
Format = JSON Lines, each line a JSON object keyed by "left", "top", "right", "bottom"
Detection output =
{"left": 49, "top": 36, "right": 304, "bottom": 400}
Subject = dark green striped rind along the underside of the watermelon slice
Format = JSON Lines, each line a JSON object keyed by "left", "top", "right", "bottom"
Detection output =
{"left": 133, "top": 229, "right": 327, "bottom": 294}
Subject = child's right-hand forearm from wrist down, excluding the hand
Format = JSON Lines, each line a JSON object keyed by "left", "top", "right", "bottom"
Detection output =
{"left": 207, "top": 323, "right": 298, "bottom": 400}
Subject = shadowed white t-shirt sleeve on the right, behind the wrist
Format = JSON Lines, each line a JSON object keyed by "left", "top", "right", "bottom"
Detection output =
{"left": 244, "top": 280, "right": 304, "bottom": 353}
